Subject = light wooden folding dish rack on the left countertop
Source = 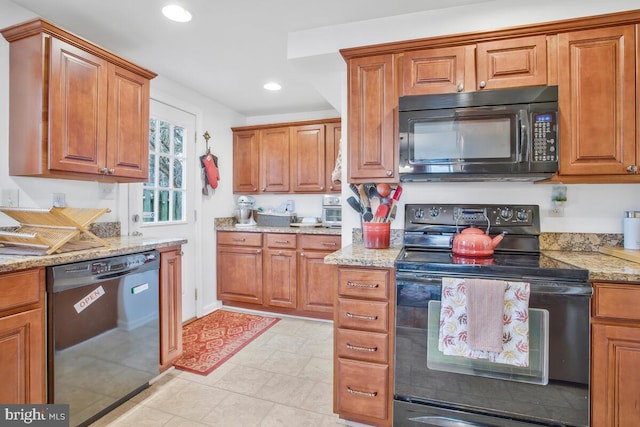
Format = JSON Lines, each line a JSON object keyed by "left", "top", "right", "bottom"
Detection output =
{"left": 0, "top": 207, "right": 110, "bottom": 255}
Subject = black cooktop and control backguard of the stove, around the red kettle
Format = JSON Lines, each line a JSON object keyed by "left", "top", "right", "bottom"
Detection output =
{"left": 396, "top": 204, "right": 589, "bottom": 281}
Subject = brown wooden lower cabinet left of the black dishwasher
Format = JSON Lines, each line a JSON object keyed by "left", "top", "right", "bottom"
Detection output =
{"left": 0, "top": 268, "right": 47, "bottom": 404}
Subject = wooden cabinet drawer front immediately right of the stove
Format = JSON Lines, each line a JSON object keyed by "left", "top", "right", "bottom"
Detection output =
{"left": 593, "top": 284, "right": 640, "bottom": 321}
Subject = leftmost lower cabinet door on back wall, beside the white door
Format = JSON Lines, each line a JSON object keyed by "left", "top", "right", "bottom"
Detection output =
{"left": 216, "top": 245, "right": 262, "bottom": 304}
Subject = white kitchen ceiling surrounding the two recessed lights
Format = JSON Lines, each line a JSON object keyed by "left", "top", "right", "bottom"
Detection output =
{"left": 6, "top": 0, "right": 481, "bottom": 116}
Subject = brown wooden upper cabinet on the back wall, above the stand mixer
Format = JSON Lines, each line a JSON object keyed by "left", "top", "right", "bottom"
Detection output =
{"left": 232, "top": 119, "right": 340, "bottom": 194}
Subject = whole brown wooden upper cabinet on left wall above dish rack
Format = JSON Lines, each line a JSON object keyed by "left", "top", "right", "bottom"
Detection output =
{"left": 2, "top": 19, "right": 156, "bottom": 182}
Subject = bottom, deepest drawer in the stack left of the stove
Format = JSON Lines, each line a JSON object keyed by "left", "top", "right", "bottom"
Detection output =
{"left": 336, "top": 359, "right": 389, "bottom": 420}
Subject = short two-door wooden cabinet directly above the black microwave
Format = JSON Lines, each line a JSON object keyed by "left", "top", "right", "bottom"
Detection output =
{"left": 402, "top": 35, "right": 547, "bottom": 95}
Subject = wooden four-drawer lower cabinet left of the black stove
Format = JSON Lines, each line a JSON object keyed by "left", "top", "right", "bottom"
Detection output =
{"left": 333, "top": 265, "right": 395, "bottom": 426}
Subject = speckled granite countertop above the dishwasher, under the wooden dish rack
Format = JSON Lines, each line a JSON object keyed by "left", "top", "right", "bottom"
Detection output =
{"left": 0, "top": 236, "right": 187, "bottom": 272}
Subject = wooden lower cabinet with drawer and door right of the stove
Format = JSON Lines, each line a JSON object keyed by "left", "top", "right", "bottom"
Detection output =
{"left": 590, "top": 283, "right": 640, "bottom": 427}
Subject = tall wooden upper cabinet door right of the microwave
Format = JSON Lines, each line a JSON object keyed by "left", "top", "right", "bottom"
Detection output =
{"left": 558, "top": 25, "right": 637, "bottom": 176}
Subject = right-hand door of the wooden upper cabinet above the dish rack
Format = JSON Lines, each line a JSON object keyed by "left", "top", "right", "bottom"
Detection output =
{"left": 106, "top": 64, "right": 149, "bottom": 180}
